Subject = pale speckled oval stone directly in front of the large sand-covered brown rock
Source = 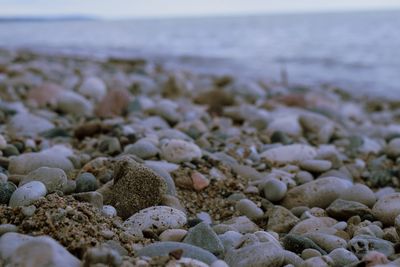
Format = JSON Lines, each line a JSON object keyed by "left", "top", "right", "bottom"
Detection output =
{"left": 124, "top": 206, "right": 187, "bottom": 235}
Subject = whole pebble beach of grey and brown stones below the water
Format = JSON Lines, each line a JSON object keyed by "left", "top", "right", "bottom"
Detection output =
{"left": 0, "top": 49, "right": 400, "bottom": 267}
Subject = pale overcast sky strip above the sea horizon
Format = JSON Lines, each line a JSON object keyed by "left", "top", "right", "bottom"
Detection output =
{"left": 0, "top": 0, "right": 400, "bottom": 18}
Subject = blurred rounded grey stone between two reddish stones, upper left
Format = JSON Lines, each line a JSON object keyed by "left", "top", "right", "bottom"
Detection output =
{"left": 57, "top": 90, "right": 93, "bottom": 116}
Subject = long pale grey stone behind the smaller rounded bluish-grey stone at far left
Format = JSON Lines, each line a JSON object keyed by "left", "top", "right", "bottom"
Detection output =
{"left": 8, "top": 146, "right": 74, "bottom": 174}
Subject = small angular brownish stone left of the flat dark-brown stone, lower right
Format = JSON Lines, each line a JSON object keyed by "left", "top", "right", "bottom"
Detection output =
{"left": 267, "top": 206, "right": 300, "bottom": 233}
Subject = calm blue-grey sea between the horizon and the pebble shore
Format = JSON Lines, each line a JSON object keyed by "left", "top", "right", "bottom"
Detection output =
{"left": 0, "top": 11, "right": 400, "bottom": 96}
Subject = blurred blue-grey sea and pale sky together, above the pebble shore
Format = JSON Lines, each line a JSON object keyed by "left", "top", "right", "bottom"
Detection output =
{"left": 0, "top": 0, "right": 400, "bottom": 96}
